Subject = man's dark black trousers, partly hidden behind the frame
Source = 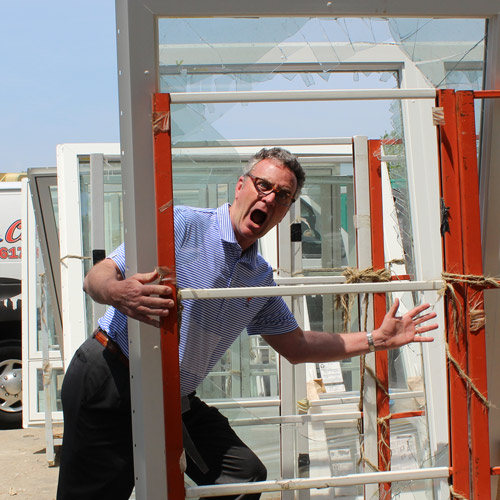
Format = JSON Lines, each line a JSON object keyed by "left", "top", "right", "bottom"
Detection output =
{"left": 57, "top": 339, "right": 267, "bottom": 500}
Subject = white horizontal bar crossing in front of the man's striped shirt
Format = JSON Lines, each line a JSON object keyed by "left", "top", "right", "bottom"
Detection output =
{"left": 179, "top": 280, "right": 443, "bottom": 300}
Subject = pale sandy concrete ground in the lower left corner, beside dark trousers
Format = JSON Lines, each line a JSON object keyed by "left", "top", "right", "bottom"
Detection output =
{"left": 0, "top": 428, "right": 59, "bottom": 500}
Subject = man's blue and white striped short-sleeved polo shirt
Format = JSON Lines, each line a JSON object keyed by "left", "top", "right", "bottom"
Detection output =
{"left": 99, "top": 204, "right": 298, "bottom": 395}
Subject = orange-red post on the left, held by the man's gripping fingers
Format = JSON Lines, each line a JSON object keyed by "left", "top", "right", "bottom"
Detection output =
{"left": 153, "top": 94, "right": 185, "bottom": 500}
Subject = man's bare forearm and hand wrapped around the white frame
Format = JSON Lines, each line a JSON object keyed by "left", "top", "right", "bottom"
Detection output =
{"left": 83, "top": 259, "right": 174, "bottom": 328}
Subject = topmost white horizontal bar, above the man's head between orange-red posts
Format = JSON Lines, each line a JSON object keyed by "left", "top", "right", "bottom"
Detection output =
{"left": 170, "top": 89, "right": 436, "bottom": 104}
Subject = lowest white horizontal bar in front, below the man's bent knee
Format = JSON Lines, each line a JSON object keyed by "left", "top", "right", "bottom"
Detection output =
{"left": 186, "top": 467, "right": 450, "bottom": 498}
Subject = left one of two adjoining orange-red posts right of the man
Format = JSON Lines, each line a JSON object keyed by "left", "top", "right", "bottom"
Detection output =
{"left": 437, "top": 90, "right": 470, "bottom": 498}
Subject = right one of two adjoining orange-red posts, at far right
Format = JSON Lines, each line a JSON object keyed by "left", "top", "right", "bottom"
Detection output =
{"left": 456, "top": 91, "right": 490, "bottom": 500}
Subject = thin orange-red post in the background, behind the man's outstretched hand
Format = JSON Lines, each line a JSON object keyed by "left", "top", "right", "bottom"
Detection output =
{"left": 368, "top": 140, "right": 391, "bottom": 499}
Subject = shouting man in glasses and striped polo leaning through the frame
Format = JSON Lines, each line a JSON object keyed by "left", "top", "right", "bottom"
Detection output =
{"left": 58, "top": 148, "right": 437, "bottom": 500}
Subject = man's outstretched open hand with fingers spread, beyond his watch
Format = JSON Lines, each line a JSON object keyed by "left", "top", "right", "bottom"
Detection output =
{"left": 373, "top": 299, "right": 438, "bottom": 349}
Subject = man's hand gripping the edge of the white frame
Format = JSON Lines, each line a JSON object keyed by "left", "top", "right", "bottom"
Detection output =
{"left": 110, "top": 271, "right": 174, "bottom": 327}
